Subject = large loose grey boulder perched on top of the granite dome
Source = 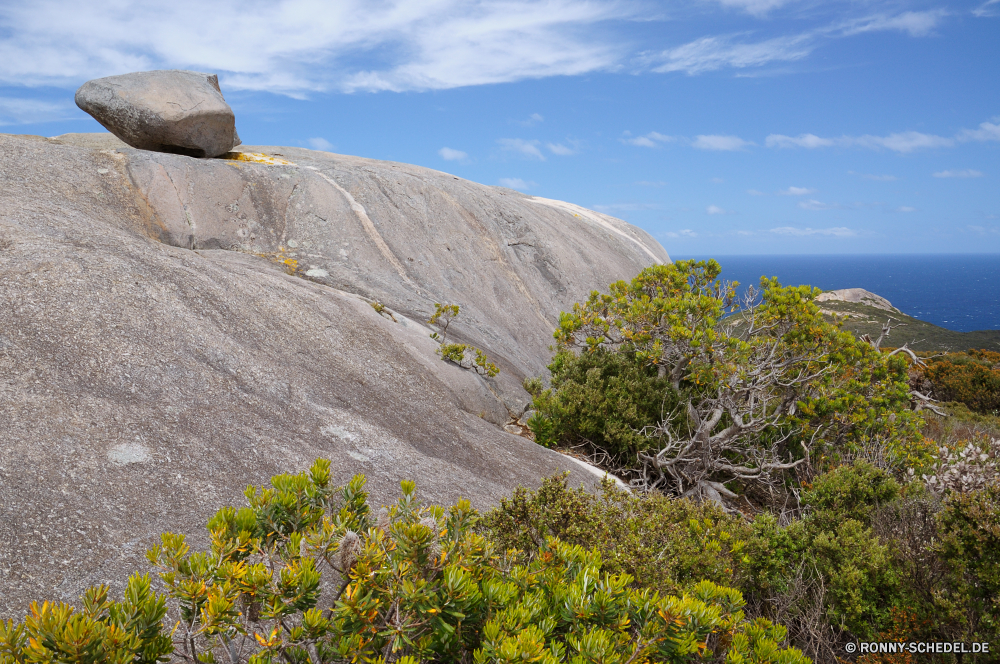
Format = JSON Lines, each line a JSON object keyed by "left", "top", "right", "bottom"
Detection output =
{"left": 76, "top": 69, "right": 240, "bottom": 157}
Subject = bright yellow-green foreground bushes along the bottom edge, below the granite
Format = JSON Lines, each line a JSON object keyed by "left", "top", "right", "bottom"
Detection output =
{"left": 0, "top": 460, "right": 808, "bottom": 664}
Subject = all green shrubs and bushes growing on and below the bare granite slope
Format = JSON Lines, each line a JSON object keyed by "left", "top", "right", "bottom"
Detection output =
{"left": 0, "top": 261, "right": 1000, "bottom": 664}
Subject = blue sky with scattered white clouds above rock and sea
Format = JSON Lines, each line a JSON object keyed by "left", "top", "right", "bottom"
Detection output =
{"left": 0, "top": 0, "right": 1000, "bottom": 255}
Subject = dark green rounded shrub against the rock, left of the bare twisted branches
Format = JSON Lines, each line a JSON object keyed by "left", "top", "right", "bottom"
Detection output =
{"left": 528, "top": 350, "right": 677, "bottom": 456}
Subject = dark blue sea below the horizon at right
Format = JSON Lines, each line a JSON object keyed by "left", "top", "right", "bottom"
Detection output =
{"left": 671, "top": 254, "right": 1000, "bottom": 332}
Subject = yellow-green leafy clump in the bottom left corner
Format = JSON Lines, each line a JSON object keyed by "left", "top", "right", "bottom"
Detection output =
{"left": 0, "top": 574, "right": 173, "bottom": 664}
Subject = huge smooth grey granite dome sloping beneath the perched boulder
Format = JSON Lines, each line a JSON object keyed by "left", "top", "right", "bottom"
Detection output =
{"left": 0, "top": 135, "right": 669, "bottom": 617}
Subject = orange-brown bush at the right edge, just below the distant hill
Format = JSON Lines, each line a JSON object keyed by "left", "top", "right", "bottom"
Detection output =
{"left": 917, "top": 350, "right": 1000, "bottom": 414}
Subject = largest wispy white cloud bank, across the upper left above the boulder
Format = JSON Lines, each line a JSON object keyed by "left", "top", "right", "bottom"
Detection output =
{"left": 0, "top": 0, "right": 641, "bottom": 95}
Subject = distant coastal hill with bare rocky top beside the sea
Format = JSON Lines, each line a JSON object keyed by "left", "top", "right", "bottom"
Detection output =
{"left": 816, "top": 288, "right": 1000, "bottom": 352}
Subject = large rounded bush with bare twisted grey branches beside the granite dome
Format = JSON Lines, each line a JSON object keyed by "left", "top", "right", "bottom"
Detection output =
{"left": 529, "top": 261, "right": 925, "bottom": 503}
